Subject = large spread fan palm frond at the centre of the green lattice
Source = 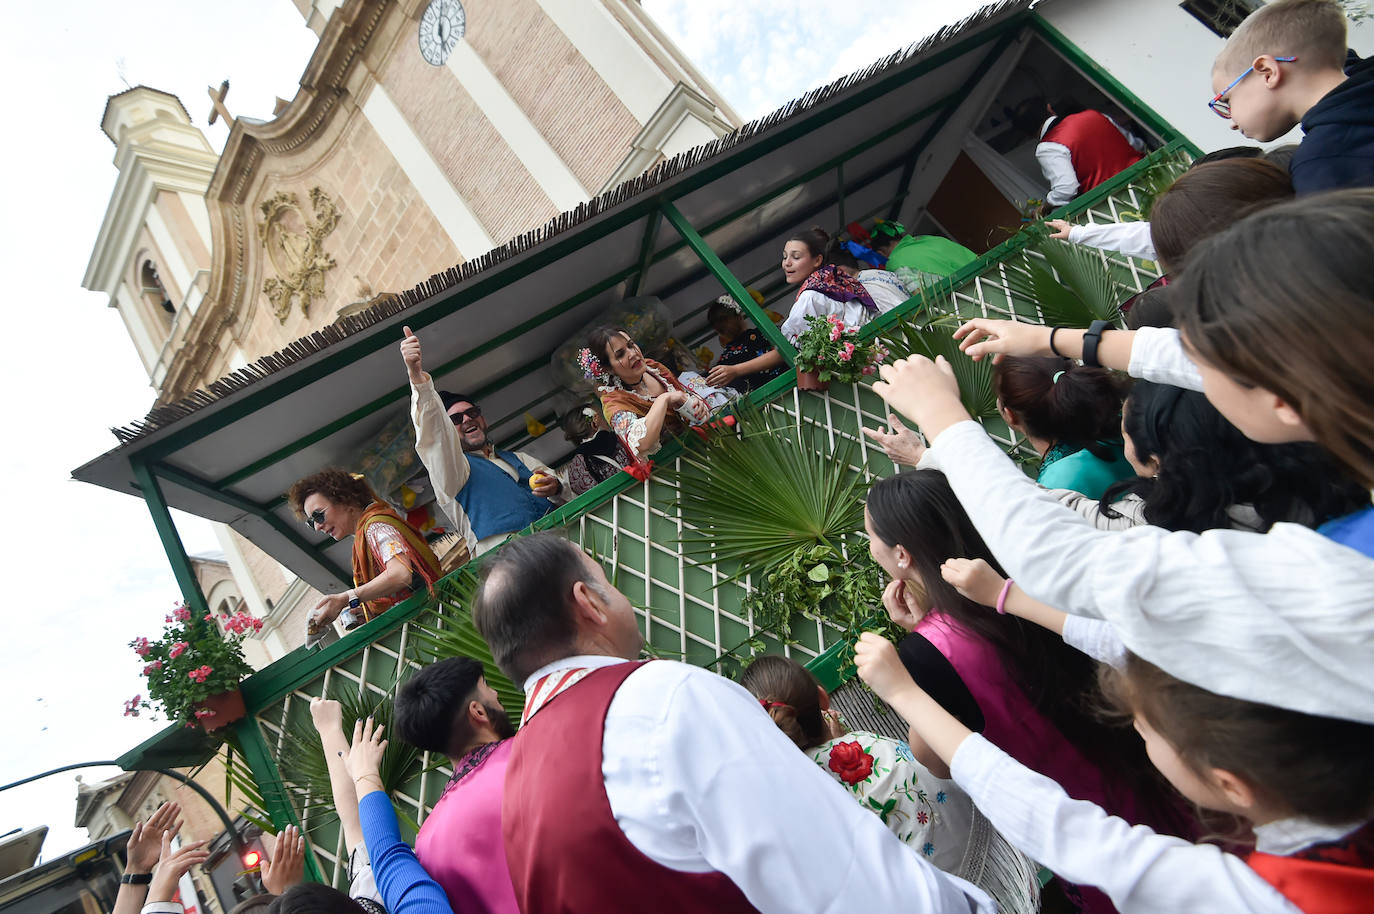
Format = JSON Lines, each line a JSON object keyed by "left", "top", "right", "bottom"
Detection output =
{"left": 664, "top": 405, "right": 866, "bottom": 580}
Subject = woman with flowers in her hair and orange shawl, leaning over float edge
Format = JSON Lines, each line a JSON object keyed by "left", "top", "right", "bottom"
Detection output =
{"left": 578, "top": 327, "right": 710, "bottom": 462}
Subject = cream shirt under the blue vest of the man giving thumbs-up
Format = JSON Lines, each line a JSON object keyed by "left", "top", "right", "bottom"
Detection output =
{"left": 411, "top": 379, "right": 572, "bottom": 558}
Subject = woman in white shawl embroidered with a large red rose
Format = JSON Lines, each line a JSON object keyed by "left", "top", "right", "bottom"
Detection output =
{"left": 739, "top": 654, "right": 1040, "bottom": 913}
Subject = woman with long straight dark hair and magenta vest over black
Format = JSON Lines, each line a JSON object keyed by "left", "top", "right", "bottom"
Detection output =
{"left": 864, "top": 470, "right": 1193, "bottom": 911}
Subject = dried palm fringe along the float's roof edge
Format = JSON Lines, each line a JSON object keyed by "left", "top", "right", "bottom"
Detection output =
{"left": 110, "top": 0, "right": 1032, "bottom": 447}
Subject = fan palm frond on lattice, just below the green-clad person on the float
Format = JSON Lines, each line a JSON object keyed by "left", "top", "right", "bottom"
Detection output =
{"left": 1006, "top": 238, "right": 1135, "bottom": 327}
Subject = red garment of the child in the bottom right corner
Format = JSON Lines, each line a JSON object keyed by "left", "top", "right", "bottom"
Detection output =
{"left": 1245, "top": 825, "right": 1374, "bottom": 914}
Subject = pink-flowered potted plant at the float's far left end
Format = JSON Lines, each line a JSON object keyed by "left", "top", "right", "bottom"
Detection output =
{"left": 124, "top": 603, "right": 262, "bottom": 727}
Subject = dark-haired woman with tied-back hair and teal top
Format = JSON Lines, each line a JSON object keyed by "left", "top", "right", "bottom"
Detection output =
{"left": 992, "top": 359, "right": 1134, "bottom": 499}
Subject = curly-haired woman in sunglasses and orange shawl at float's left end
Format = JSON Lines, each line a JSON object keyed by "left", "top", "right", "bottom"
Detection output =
{"left": 286, "top": 467, "right": 442, "bottom": 634}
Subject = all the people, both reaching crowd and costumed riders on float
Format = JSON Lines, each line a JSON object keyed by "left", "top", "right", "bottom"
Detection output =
{"left": 117, "top": 0, "right": 1374, "bottom": 914}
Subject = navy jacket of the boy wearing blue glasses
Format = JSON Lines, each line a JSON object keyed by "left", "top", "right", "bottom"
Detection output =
{"left": 1289, "top": 58, "right": 1374, "bottom": 194}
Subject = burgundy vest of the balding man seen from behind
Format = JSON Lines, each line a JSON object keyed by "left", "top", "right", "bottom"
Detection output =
{"left": 502, "top": 662, "right": 756, "bottom": 914}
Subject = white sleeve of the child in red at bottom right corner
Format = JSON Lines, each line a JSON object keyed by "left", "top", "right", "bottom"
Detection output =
{"left": 945, "top": 734, "right": 1297, "bottom": 914}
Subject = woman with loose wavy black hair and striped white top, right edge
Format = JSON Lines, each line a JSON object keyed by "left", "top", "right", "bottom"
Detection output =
{"left": 1054, "top": 381, "right": 1369, "bottom": 533}
